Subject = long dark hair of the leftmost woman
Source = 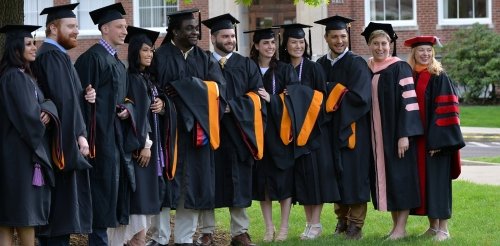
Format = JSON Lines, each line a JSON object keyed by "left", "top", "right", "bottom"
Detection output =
{"left": 0, "top": 36, "right": 35, "bottom": 78}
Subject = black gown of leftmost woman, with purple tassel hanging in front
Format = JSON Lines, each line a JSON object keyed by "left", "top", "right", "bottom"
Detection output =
{"left": 0, "top": 67, "right": 57, "bottom": 227}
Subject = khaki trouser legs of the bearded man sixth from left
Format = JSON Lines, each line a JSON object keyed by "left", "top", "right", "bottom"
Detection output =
{"left": 199, "top": 208, "right": 250, "bottom": 237}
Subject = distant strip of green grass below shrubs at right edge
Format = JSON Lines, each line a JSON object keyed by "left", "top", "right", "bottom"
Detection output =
{"left": 460, "top": 105, "right": 500, "bottom": 127}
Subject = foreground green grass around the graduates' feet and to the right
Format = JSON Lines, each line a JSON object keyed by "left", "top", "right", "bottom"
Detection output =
{"left": 212, "top": 181, "right": 500, "bottom": 245}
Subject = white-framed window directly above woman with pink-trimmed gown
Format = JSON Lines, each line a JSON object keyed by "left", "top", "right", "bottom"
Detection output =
{"left": 365, "top": 0, "right": 417, "bottom": 26}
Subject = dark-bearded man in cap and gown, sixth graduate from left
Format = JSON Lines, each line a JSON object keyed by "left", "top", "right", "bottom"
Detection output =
{"left": 196, "top": 14, "right": 264, "bottom": 245}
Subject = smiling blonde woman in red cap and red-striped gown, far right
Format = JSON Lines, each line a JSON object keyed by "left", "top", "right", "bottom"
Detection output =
{"left": 404, "top": 36, "right": 465, "bottom": 241}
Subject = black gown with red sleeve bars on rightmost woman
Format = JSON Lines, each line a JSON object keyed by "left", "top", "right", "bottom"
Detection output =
{"left": 411, "top": 70, "right": 465, "bottom": 219}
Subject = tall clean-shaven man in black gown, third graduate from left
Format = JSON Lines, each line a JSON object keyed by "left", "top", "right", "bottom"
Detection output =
{"left": 75, "top": 3, "right": 134, "bottom": 245}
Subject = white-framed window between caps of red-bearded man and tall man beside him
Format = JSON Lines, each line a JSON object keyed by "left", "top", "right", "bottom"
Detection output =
{"left": 72, "top": 0, "right": 115, "bottom": 35}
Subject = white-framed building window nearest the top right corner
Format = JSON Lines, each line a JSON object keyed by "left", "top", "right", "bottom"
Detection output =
{"left": 438, "top": 0, "right": 491, "bottom": 25}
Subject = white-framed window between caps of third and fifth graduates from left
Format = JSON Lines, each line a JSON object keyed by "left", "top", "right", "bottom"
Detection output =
{"left": 134, "top": 0, "right": 179, "bottom": 31}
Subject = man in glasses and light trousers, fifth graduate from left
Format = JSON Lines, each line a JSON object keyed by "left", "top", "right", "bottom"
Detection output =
{"left": 151, "top": 9, "right": 225, "bottom": 244}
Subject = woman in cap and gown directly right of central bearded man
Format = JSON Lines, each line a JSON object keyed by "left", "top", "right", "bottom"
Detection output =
{"left": 245, "top": 28, "right": 298, "bottom": 242}
